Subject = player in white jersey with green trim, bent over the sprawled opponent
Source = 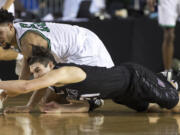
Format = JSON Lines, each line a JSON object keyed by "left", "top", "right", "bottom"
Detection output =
{"left": 0, "top": 10, "right": 114, "bottom": 112}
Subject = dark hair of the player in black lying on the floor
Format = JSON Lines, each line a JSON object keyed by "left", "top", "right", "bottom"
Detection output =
{"left": 27, "top": 45, "right": 56, "bottom": 66}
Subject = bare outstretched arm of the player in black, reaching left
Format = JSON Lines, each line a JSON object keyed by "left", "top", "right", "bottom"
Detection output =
{"left": 0, "top": 67, "right": 86, "bottom": 96}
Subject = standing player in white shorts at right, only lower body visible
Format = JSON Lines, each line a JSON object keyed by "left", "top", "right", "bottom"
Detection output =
{"left": 147, "top": 0, "right": 180, "bottom": 71}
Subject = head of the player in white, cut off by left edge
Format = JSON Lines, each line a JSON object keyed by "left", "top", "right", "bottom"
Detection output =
{"left": 0, "top": 9, "right": 15, "bottom": 47}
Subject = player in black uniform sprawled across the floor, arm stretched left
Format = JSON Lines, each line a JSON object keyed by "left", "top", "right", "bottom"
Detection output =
{"left": 0, "top": 47, "right": 180, "bottom": 112}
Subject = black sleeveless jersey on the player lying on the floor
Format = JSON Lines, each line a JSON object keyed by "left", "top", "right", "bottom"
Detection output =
{"left": 54, "top": 63, "right": 130, "bottom": 99}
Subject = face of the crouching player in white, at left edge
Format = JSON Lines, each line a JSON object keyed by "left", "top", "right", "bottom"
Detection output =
{"left": 0, "top": 24, "right": 12, "bottom": 46}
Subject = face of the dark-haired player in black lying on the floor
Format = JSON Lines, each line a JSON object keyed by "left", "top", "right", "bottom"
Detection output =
{"left": 30, "top": 62, "right": 52, "bottom": 78}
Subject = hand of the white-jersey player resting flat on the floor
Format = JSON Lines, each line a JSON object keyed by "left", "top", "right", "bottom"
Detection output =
{"left": 4, "top": 106, "right": 31, "bottom": 113}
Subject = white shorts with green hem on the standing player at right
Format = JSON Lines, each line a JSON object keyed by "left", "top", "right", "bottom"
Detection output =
{"left": 158, "top": 0, "right": 180, "bottom": 27}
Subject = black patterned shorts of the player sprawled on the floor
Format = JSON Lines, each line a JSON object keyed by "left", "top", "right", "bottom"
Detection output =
{"left": 114, "top": 64, "right": 179, "bottom": 111}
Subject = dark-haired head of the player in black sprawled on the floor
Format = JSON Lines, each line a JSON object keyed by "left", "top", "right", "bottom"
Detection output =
{"left": 28, "top": 46, "right": 56, "bottom": 78}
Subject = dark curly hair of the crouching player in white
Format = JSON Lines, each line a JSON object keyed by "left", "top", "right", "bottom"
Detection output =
{"left": 0, "top": 8, "right": 14, "bottom": 23}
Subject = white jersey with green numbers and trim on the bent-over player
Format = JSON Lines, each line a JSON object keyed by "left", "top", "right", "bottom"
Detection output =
{"left": 14, "top": 22, "right": 113, "bottom": 67}
